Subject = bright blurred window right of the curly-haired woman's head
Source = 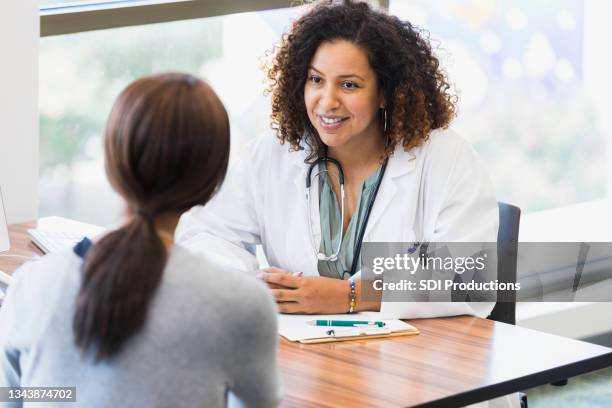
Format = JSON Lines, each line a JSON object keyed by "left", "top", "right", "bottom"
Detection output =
{"left": 390, "top": 0, "right": 611, "bottom": 211}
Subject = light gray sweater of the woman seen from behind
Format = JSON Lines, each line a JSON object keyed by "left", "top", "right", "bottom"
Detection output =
{"left": 0, "top": 246, "right": 281, "bottom": 408}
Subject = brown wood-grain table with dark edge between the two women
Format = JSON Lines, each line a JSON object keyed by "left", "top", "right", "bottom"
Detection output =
{"left": 0, "top": 223, "right": 612, "bottom": 408}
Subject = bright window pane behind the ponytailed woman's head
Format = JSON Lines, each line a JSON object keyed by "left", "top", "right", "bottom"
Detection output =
{"left": 40, "top": 4, "right": 299, "bottom": 225}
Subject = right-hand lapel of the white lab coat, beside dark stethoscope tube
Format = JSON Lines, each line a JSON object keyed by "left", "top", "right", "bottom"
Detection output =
{"left": 364, "top": 146, "right": 416, "bottom": 241}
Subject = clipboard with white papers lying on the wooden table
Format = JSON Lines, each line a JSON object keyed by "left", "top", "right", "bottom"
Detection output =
{"left": 278, "top": 313, "right": 419, "bottom": 343}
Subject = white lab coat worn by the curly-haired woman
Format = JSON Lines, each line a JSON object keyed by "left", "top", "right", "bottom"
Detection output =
{"left": 176, "top": 130, "right": 499, "bottom": 319}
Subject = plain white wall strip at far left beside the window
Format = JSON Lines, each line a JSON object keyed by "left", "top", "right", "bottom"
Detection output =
{"left": 0, "top": 0, "right": 40, "bottom": 223}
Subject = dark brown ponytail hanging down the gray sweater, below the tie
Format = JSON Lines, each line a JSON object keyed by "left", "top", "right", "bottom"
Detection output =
{"left": 73, "top": 216, "right": 167, "bottom": 360}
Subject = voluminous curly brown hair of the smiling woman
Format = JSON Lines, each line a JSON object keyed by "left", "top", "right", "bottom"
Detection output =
{"left": 265, "top": 0, "right": 457, "bottom": 162}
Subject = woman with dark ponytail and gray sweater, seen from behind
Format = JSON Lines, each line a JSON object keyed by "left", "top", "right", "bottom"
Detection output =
{"left": 0, "top": 73, "right": 280, "bottom": 408}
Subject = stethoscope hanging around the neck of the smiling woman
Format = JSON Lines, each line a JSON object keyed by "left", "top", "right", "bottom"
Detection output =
{"left": 306, "top": 156, "right": 389, "bottom": 276}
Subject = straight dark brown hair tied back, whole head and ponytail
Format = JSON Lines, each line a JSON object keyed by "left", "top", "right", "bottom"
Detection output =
{"left": 73, "top": 73, "right": 229, "bottom": 360}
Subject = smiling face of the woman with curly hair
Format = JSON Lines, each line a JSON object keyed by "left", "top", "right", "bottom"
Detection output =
{"left": 304, "top": 40, "right": 384, "bottom": 151}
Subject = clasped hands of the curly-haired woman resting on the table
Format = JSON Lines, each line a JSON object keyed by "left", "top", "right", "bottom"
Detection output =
{"left": 258, "top": 267, "right": 350, "bottom": 314}
